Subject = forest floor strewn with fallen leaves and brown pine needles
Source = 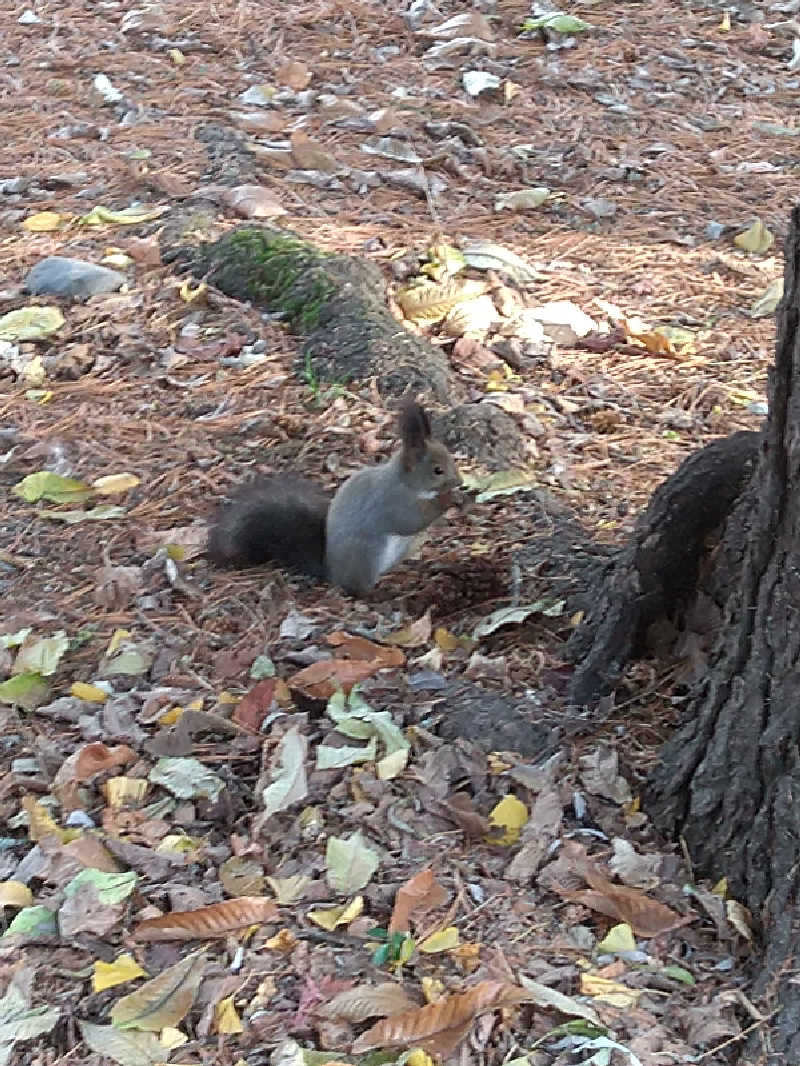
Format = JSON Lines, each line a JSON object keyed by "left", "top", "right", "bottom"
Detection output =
{"left": 0, "top": 0, "right": 800, "bottom": 1066}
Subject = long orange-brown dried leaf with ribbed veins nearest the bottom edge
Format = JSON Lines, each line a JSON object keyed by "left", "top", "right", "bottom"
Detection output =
{"left": 352, "top": 981, "right": 530, "bottom": 1054}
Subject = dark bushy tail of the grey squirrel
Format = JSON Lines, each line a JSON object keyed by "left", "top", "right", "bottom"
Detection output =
{"left": 208, "top": 474, "right": 331, "bottom": 578}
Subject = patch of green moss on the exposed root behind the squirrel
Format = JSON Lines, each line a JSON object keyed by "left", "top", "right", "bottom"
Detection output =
{"left": 218, "top": 228, "right": 336, "bottom": 333}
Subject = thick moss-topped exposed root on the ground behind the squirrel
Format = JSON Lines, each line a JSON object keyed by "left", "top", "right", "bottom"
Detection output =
{"left": 191, "top": 226, "right": 464, "bottom": 404}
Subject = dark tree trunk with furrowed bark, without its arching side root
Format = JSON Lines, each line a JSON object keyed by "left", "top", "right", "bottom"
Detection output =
{"left": 646, "top": 208, "right": 800, "bottom": 1066}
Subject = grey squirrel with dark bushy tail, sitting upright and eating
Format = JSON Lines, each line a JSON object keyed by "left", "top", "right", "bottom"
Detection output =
{"left": 208, "top": 400, "right": 461, "bottom": 596}
